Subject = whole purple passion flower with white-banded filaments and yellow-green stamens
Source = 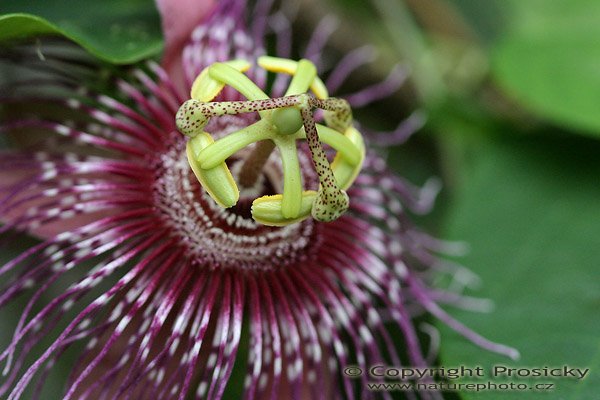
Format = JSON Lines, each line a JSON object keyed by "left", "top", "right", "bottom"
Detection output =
{"left": 0, "top": 1, "right": 516, "bottom": 400}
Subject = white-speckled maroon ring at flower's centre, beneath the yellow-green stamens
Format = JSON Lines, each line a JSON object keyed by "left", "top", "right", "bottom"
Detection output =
{"left": 153, "top": 130, "right": 319, "bottom": 270}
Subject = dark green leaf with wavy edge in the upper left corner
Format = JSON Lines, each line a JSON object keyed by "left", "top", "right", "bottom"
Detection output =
{"left": 0, "top": 0, "right": 162, "bottom": 64}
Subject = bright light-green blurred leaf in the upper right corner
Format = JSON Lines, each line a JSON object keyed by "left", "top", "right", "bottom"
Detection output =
{"left": 492, "top": 0, "right": 600, "bottom": 136}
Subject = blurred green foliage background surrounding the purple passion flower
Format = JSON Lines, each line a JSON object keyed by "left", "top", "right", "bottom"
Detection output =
{"left": 0, "top": 0, "right": 600, "bottom": 400}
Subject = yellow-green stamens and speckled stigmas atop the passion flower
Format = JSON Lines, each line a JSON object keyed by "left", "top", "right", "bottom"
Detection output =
{"left": 176, "top": 56, "right": 365, "bottom": 226}
